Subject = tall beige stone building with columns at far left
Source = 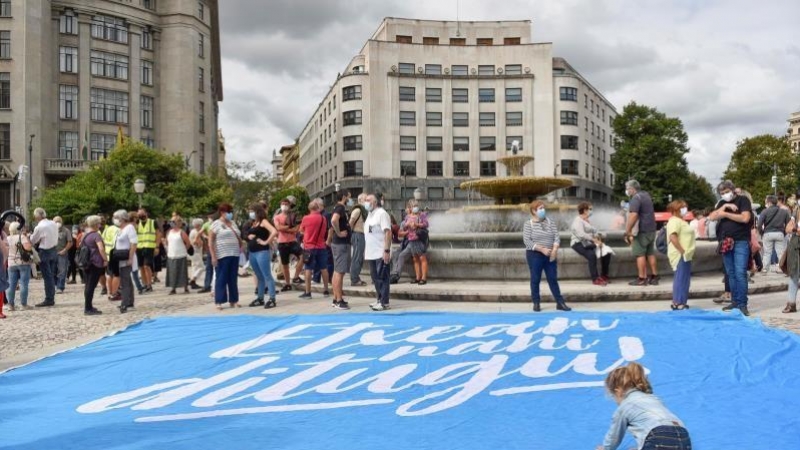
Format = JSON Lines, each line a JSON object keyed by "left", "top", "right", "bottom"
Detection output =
{"left": 0, "top": 0, "right": 222, "bottom": 213}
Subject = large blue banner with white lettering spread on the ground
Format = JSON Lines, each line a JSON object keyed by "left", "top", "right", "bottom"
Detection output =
{"left": 0, "top": 311, "right": 800, "bottom": 450}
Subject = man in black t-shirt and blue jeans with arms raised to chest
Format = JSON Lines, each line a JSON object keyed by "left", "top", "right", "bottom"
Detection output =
{"left": 709, "top": 181, "right": 753, "bottom": 316}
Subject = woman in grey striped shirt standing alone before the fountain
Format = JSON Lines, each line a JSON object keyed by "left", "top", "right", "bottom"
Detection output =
{"left": 522, "top": 200, "right": 572, "bottom": 312}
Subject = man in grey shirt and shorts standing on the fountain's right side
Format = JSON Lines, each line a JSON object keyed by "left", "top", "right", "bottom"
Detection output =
{"left": 625, "top": 180, "right": 659, "bottom": 286}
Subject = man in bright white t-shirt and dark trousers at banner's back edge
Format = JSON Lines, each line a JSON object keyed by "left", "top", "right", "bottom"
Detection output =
{"left": 364, "top": 195, "right": 392, "bottom": 311}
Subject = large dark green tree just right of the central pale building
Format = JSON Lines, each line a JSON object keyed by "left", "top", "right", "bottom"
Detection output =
{"left": 611, "top": 102, "right": 714, "bottom": 209}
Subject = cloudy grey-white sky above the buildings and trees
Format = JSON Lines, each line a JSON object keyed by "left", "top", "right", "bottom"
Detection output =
{"left": 220, "top": 0, "right": 800, "bottom": 183}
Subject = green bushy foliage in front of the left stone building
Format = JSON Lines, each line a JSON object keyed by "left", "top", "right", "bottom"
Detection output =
{"left": 35, "top": 140, "right": 231, "bottom": 223}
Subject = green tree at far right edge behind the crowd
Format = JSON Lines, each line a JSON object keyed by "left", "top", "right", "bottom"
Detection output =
{"left": 723, "top": 134, "right": 800, "bottom": 203}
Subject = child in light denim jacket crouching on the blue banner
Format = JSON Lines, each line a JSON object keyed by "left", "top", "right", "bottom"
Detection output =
{"left": 597, "top": 363, "right": 692, "bottom": 450}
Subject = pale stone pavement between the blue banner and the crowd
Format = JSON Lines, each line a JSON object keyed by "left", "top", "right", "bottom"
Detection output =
{"left": 0, "top": 275, "right": 800, "bottom": 371}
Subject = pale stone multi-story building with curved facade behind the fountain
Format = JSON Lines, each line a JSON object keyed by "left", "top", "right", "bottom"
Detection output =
{"left": 298, "top": 18, "right": 616, "bottom": 213}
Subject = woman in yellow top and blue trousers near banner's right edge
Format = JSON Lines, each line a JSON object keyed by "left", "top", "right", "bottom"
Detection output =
{"left": 667, "top": 200, "right": 696, "bottom": 310}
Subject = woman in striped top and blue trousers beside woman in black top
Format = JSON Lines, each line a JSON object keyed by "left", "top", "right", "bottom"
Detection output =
{"left": 208, "top": 203, "right": 242, "bottom": 310}
